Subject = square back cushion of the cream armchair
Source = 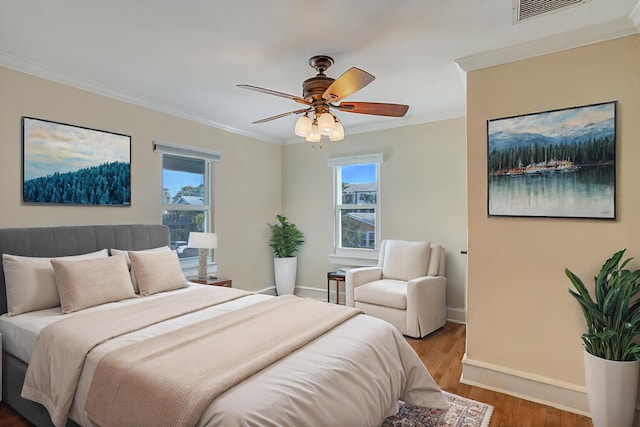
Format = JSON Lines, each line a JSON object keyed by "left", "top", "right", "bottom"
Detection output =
{"left": 382, "top": 240, "right": 431, "bottom": 281}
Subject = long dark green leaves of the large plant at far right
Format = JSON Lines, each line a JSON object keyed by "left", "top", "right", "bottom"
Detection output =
{"left": 564, "top": 249, "right": 640, "bottom": 361}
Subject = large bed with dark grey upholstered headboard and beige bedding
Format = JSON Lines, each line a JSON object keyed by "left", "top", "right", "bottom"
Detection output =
{"left": 0, "top": 224, "right": 447, "bottom": 426}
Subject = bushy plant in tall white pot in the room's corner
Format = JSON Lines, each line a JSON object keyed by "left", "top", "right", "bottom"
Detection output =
{"left": 268, "top": 215, "right": 304, "bottom": 295}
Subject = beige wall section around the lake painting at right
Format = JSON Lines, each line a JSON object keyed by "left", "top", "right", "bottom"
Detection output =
{"left": 467, "top": 36, "right": 640, "bottom": 388}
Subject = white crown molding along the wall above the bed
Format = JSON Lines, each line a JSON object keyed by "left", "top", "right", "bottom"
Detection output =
{"left": 0, "top": 51, "right": 281, "bottom": 144}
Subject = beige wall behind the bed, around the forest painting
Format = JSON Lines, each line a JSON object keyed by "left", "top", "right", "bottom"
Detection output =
{"left": 0, "top": 67, "right": 282, "bottom": 290}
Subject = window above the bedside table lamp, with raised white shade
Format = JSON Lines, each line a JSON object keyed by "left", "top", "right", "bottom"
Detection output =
{"left": 155, "top": 141, "right": 220, "bottom": 266}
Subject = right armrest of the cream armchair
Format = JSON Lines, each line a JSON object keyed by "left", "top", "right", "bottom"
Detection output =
{"left": 407, "top": 276, "right": 447, "bottom": 337}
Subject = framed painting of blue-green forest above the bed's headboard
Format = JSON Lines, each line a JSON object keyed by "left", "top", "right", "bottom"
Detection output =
{"left": 22, "top": 117, "right": 131, "bottom": 206}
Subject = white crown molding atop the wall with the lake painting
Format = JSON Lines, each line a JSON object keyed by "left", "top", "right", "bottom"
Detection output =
{"left": 455, "top": 16, "right": 640, "bottom": 72}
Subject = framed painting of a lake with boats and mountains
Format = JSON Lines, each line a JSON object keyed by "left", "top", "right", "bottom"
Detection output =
{"left": 487, "top": 101, "right": 617, "bottom": 220}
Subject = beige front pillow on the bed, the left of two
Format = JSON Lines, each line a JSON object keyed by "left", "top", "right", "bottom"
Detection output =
{"left": 51, "top": 255, "right": 136, "bottom": 314}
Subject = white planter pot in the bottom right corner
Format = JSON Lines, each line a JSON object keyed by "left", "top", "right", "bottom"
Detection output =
{"left": 584, "top": 350, "right": 640, "bottom": 427}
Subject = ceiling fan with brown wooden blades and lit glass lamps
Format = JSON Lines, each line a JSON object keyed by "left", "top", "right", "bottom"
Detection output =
{"left": 237, "top": 55, "right": 409, "bottom": 143}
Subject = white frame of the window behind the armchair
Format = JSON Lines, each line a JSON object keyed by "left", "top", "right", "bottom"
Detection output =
{"left": 329, "top": 153, "right": 384, "bottom": 266}
